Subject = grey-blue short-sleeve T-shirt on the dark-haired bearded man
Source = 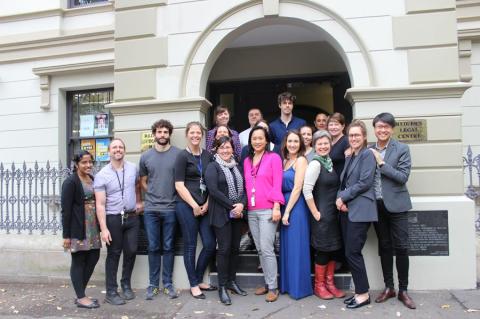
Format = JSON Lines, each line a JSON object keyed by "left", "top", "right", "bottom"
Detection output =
{"left": 139, "top": 146, "right": 181, "bottom": 212}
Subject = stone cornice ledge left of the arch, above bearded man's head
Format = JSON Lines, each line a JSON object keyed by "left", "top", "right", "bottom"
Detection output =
{"left": 106, "top": 97, "right": 212, "bottom": 115}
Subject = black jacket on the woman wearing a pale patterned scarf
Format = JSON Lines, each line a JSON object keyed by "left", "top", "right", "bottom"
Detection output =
{"left": 205, "top": 162, "right": 247, "bottom": 227}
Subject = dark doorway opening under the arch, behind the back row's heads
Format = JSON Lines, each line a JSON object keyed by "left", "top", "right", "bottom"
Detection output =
{"left": 208, "top": 73, "right": 352, "bottom": 132}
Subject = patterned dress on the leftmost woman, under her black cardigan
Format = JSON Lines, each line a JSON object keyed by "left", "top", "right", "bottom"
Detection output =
{"left": 70, "top": 182, "right": 102, "bottom": 253}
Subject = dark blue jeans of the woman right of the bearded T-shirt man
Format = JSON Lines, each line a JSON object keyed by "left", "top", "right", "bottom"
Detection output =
{"left": 176, "top": 202, "right": 216, "bottom": 287}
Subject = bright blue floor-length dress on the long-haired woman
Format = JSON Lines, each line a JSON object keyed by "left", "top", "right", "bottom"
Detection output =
{"left": 280, "top": 167, "right": 313, "bottom": 299}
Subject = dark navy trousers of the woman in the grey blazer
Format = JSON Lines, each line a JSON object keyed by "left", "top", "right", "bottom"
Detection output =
{"left": 340, "top": 213, "right": 370, "bottom": 294}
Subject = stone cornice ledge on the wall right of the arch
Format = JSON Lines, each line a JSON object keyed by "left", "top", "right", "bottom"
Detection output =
{"left": 345, "top": 82, "right": 471, "bottom": 105}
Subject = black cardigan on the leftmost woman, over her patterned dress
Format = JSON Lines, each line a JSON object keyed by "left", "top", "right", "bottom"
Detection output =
{"left": 61, "top": 173, "right": 93, "bottom": 240}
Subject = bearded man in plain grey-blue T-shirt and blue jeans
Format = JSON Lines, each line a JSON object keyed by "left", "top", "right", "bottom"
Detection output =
{"left": 140, "top": 119, "right": 184, "bottom": 300}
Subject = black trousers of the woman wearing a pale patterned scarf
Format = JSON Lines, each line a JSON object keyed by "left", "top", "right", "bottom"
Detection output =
{"left": 213, "top": 219, "right": 242, "bottom": 286}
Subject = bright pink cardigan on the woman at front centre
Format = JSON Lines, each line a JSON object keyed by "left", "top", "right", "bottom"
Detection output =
{"left": 243, "top": 152, "right": 285, "bottom": 210}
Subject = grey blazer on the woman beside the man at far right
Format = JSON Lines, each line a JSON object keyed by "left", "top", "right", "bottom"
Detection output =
{"left": 338, "top": 148, "right": 378, "bottom": 222}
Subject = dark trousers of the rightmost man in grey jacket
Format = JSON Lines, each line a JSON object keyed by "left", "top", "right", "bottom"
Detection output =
{"left": 373, "top": 200, "right": 410, "bottom": 291}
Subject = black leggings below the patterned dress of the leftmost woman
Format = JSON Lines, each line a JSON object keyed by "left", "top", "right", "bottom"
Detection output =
{"left": 70, "top": 249, "right": 100, "bottom": 299}
